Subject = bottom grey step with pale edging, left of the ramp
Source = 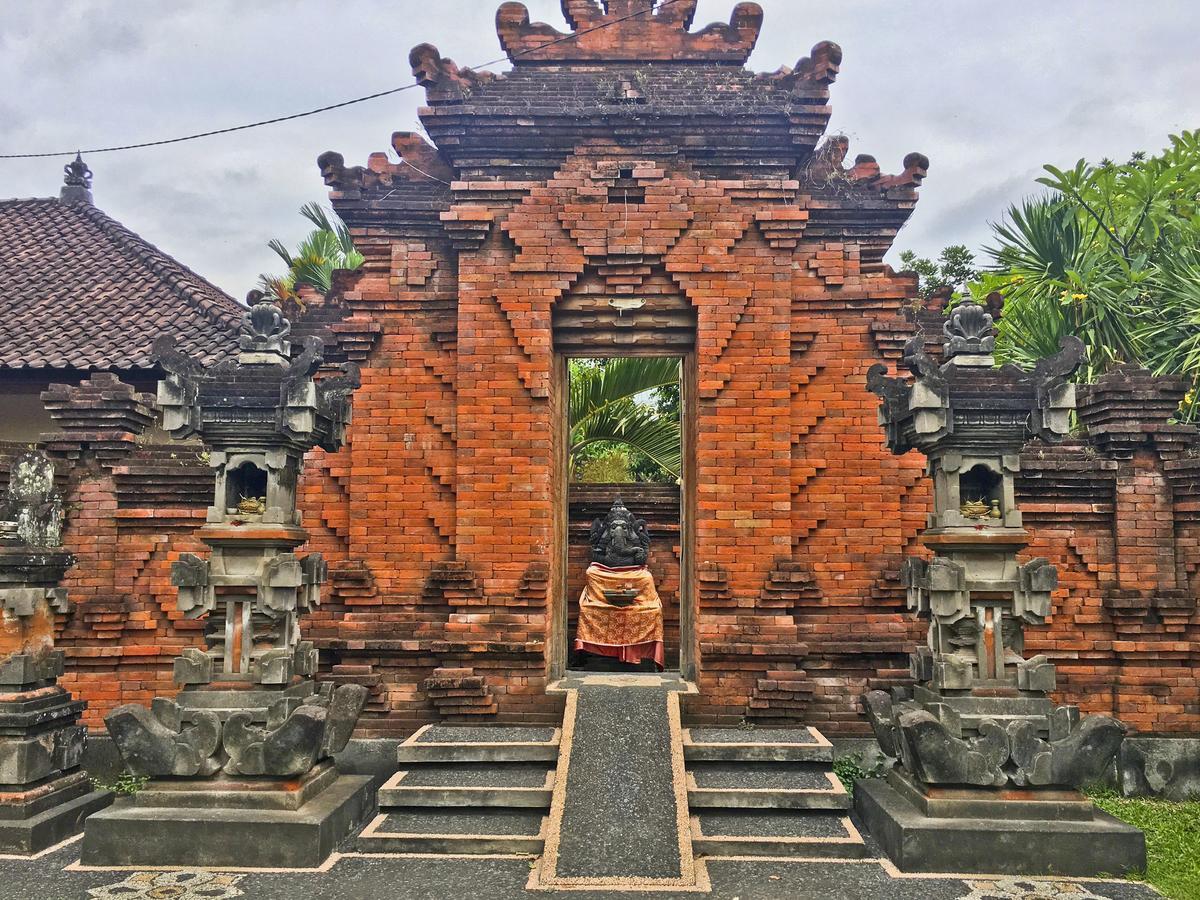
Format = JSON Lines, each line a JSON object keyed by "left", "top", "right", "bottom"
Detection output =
{"left": 355, "top": 809, "right": 546, "bottom": 856}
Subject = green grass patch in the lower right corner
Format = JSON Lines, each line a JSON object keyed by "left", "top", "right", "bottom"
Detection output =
{"left": 1088, "top": 791, "right": 1200, "bottom": 900}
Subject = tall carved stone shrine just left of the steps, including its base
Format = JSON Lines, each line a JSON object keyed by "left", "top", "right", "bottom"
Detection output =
{"left": 83, "top": 300, "right": 371, "bottom": 866}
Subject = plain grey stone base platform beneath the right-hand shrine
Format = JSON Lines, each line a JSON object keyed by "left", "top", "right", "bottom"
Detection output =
{"left": 854, "top": 779, "right": 1146, "bottom": 877}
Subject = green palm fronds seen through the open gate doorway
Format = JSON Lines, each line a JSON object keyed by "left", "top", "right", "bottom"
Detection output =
{"left": 570, "top": 358, "right": 683, "bottom": 481}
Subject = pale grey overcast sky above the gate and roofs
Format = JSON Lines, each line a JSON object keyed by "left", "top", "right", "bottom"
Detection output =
{"left": 0, "top": 0, "right": 1200, "bottom": 298}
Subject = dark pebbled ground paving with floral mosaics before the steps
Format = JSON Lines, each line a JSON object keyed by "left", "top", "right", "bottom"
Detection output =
{"left": 0, "top": 841, "right": 1159, "bottom": 900}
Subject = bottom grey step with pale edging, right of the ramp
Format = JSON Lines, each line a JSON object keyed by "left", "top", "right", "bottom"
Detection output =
{"left": 691, "top": 810, "right": 866, "bottom": 859}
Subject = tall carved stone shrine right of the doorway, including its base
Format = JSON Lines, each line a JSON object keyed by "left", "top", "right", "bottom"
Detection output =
{"left": 856, "top": 302, "right": 1146, "bottom": 875}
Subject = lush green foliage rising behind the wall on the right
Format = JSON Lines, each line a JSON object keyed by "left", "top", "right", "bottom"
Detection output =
{"left": 972, "top": 131, "right": 1200, "bottom": 419}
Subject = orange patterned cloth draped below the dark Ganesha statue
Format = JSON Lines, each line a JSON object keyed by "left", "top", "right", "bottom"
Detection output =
{"left": 575, "top": 563, "right": 666, "bottom": 668}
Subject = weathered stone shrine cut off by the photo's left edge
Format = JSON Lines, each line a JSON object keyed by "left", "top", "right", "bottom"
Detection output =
{"left": 0, "top": 452, "right": 110, "bottom": 853}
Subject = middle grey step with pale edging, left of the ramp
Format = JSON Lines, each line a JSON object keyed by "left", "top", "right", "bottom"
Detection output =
{"left": 379, "top": 763, "right": 554, "bottom": 811}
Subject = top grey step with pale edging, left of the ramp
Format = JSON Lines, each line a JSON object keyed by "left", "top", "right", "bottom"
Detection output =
{"left": 396, "top": 725, "right": 562, "bottom": 766}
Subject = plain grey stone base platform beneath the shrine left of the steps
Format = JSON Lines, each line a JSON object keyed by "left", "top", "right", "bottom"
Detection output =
{"left": 82, "top": 775, "right": 374, "bottom": 869}
